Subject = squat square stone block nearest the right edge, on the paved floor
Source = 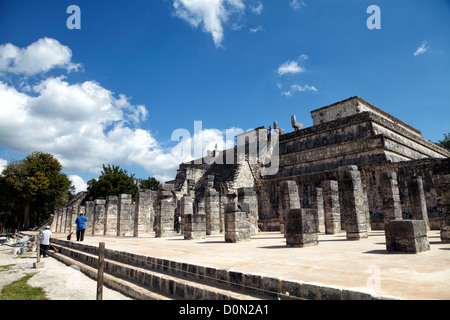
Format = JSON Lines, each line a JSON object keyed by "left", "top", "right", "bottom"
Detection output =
{"left": 385, "top": 220, "right": 430, "bottom": 253}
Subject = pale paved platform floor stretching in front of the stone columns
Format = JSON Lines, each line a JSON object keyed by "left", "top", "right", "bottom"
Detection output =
{"left": 54, "top": 230, "right": 450, "bottom": 300}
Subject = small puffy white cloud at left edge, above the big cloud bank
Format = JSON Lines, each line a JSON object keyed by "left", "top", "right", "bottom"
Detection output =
{"left": 0, "top": 38, "right": 81, "bottom": 75}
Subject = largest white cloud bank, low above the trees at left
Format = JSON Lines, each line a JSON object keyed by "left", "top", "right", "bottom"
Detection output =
{"left": 0, "top": 37, "right": 250, "bottom": 184}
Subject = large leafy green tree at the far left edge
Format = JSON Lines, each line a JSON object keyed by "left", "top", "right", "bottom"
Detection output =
{"left": 0, "top": 152, "right": 71, "bottom": 230}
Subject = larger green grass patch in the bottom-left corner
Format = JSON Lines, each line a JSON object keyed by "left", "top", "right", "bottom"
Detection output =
{"left": 0, "top": 273, "right": 48, "bottom": 300}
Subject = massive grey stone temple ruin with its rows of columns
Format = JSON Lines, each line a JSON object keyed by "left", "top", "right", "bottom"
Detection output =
{"left": 52, "top": 97, "right": 450, "bottom": 252}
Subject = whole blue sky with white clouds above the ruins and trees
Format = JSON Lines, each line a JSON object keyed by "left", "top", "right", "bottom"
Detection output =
{"left": 0, "top": 0, "right": 450, "bottom": 190}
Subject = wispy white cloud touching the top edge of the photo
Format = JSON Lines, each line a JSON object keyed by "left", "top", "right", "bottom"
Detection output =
{"left": 173, "top": 0, "right": 245, "bottom": 47}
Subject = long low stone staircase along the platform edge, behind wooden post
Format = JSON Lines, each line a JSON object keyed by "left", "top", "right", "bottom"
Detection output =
{"left": 49, "top": 239, "right": 284, "bottom": 300}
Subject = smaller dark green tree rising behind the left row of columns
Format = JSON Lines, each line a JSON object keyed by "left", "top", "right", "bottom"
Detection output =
{"left": 87, "top": 165, "right": 138, "bottom": 199}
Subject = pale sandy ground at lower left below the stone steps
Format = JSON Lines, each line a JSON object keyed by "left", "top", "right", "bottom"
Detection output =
{"left": 0, "top": 245, "right": 131, "bottom": 300}
